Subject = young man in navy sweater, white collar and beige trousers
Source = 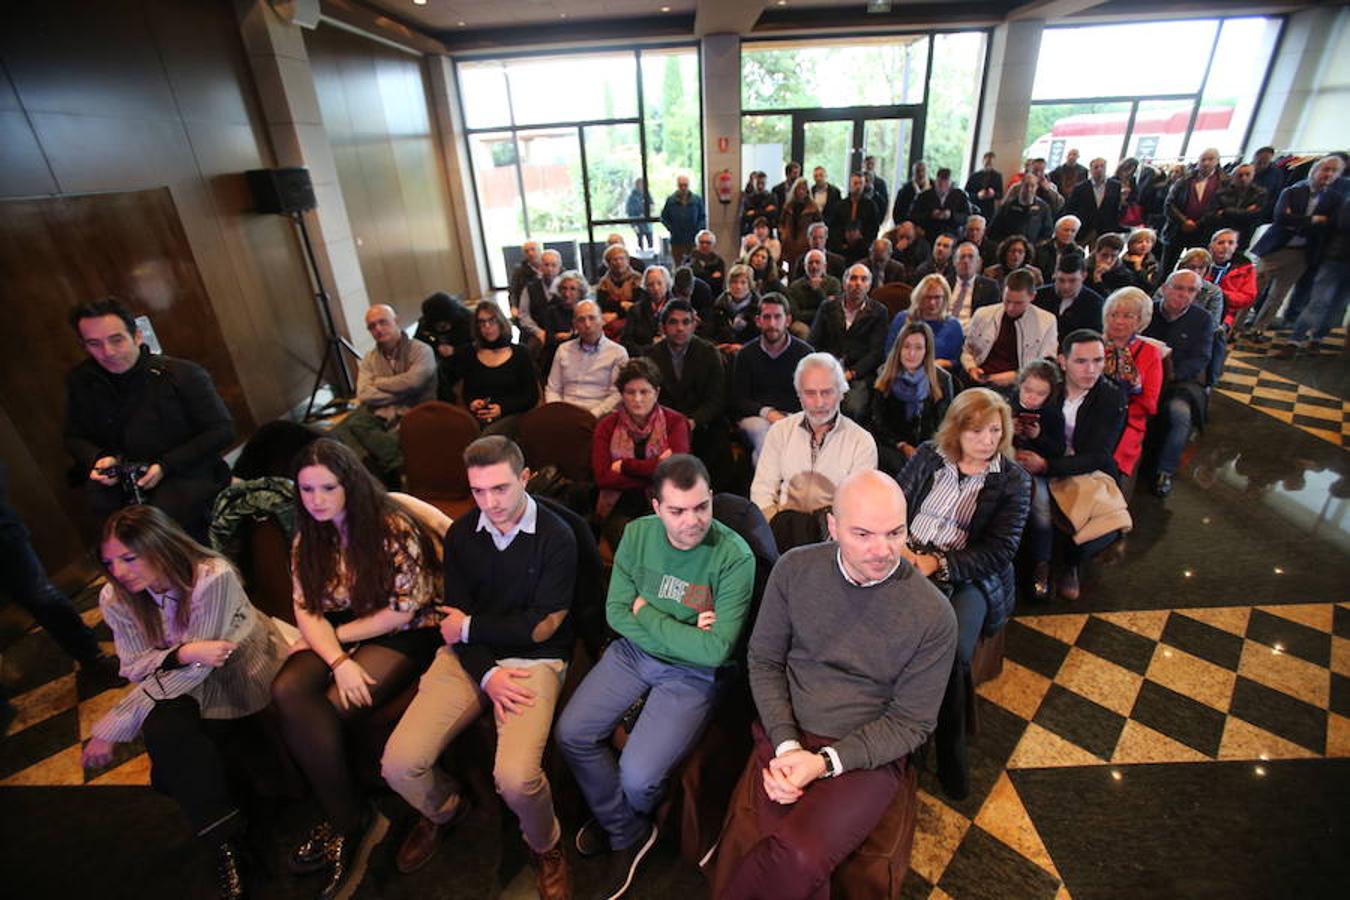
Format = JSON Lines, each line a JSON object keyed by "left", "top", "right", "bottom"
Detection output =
{"left": 382, "top": 436, "right": 576, "bottom": 900}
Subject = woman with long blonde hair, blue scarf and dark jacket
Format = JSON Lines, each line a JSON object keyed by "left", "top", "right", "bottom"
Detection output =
{"left": 869, "top": 320, "right": 956, "bottom": 475}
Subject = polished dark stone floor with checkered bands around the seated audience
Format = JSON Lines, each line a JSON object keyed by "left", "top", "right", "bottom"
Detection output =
{"left": 0, "top": 333, "right": 1350, "bottom": 900}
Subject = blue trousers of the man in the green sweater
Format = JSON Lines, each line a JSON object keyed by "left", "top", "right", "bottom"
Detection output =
{"left": 555, "top": 638, "right": 717, "bottom": 850}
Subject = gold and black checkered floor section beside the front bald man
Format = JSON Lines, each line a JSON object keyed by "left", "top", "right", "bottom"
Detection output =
{"left": 906, "top": 603, "right": 1350, "bottom": 899}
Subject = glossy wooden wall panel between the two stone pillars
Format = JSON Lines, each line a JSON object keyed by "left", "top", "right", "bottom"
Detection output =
{"left": 305, "top": 26, "right": 464, "bottom": 322}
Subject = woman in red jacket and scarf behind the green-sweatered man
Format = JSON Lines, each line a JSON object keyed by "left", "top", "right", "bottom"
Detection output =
{"left": 591, "top": 356, "right": 689, "bottom": 549}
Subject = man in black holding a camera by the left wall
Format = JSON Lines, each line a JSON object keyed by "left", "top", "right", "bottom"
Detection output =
{"left": 65, "top": 297, "right": 235, "bottom": 542}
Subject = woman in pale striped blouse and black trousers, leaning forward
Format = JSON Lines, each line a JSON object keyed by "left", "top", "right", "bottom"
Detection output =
{"left": 82, "top": 506, "right": 286, "bottom": 897}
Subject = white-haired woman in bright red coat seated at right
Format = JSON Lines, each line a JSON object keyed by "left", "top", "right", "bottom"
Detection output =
{"left": 1102, "top": 287, "right": 1162, "bottom": 478}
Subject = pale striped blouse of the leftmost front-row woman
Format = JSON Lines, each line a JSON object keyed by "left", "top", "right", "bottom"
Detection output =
{"left": 92, "top": 557, "right": 286, "bottom": 742}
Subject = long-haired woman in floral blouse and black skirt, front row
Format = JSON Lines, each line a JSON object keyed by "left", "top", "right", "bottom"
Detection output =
{"left": 271, "top": 439, "right": 441, "bottom": 900}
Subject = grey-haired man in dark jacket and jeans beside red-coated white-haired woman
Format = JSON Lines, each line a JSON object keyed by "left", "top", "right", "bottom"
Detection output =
{"left": 1143, "top": 269, "right": 1214, "bottom": 497}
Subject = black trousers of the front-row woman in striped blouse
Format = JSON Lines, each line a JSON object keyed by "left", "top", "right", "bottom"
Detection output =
{"left": 140, "top": 696, "right": 266, "bottom": 845}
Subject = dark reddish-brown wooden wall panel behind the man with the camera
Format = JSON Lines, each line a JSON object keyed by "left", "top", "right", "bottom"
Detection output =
{"left": 0, "top": 188, "right": 252, "bottom": 555}
